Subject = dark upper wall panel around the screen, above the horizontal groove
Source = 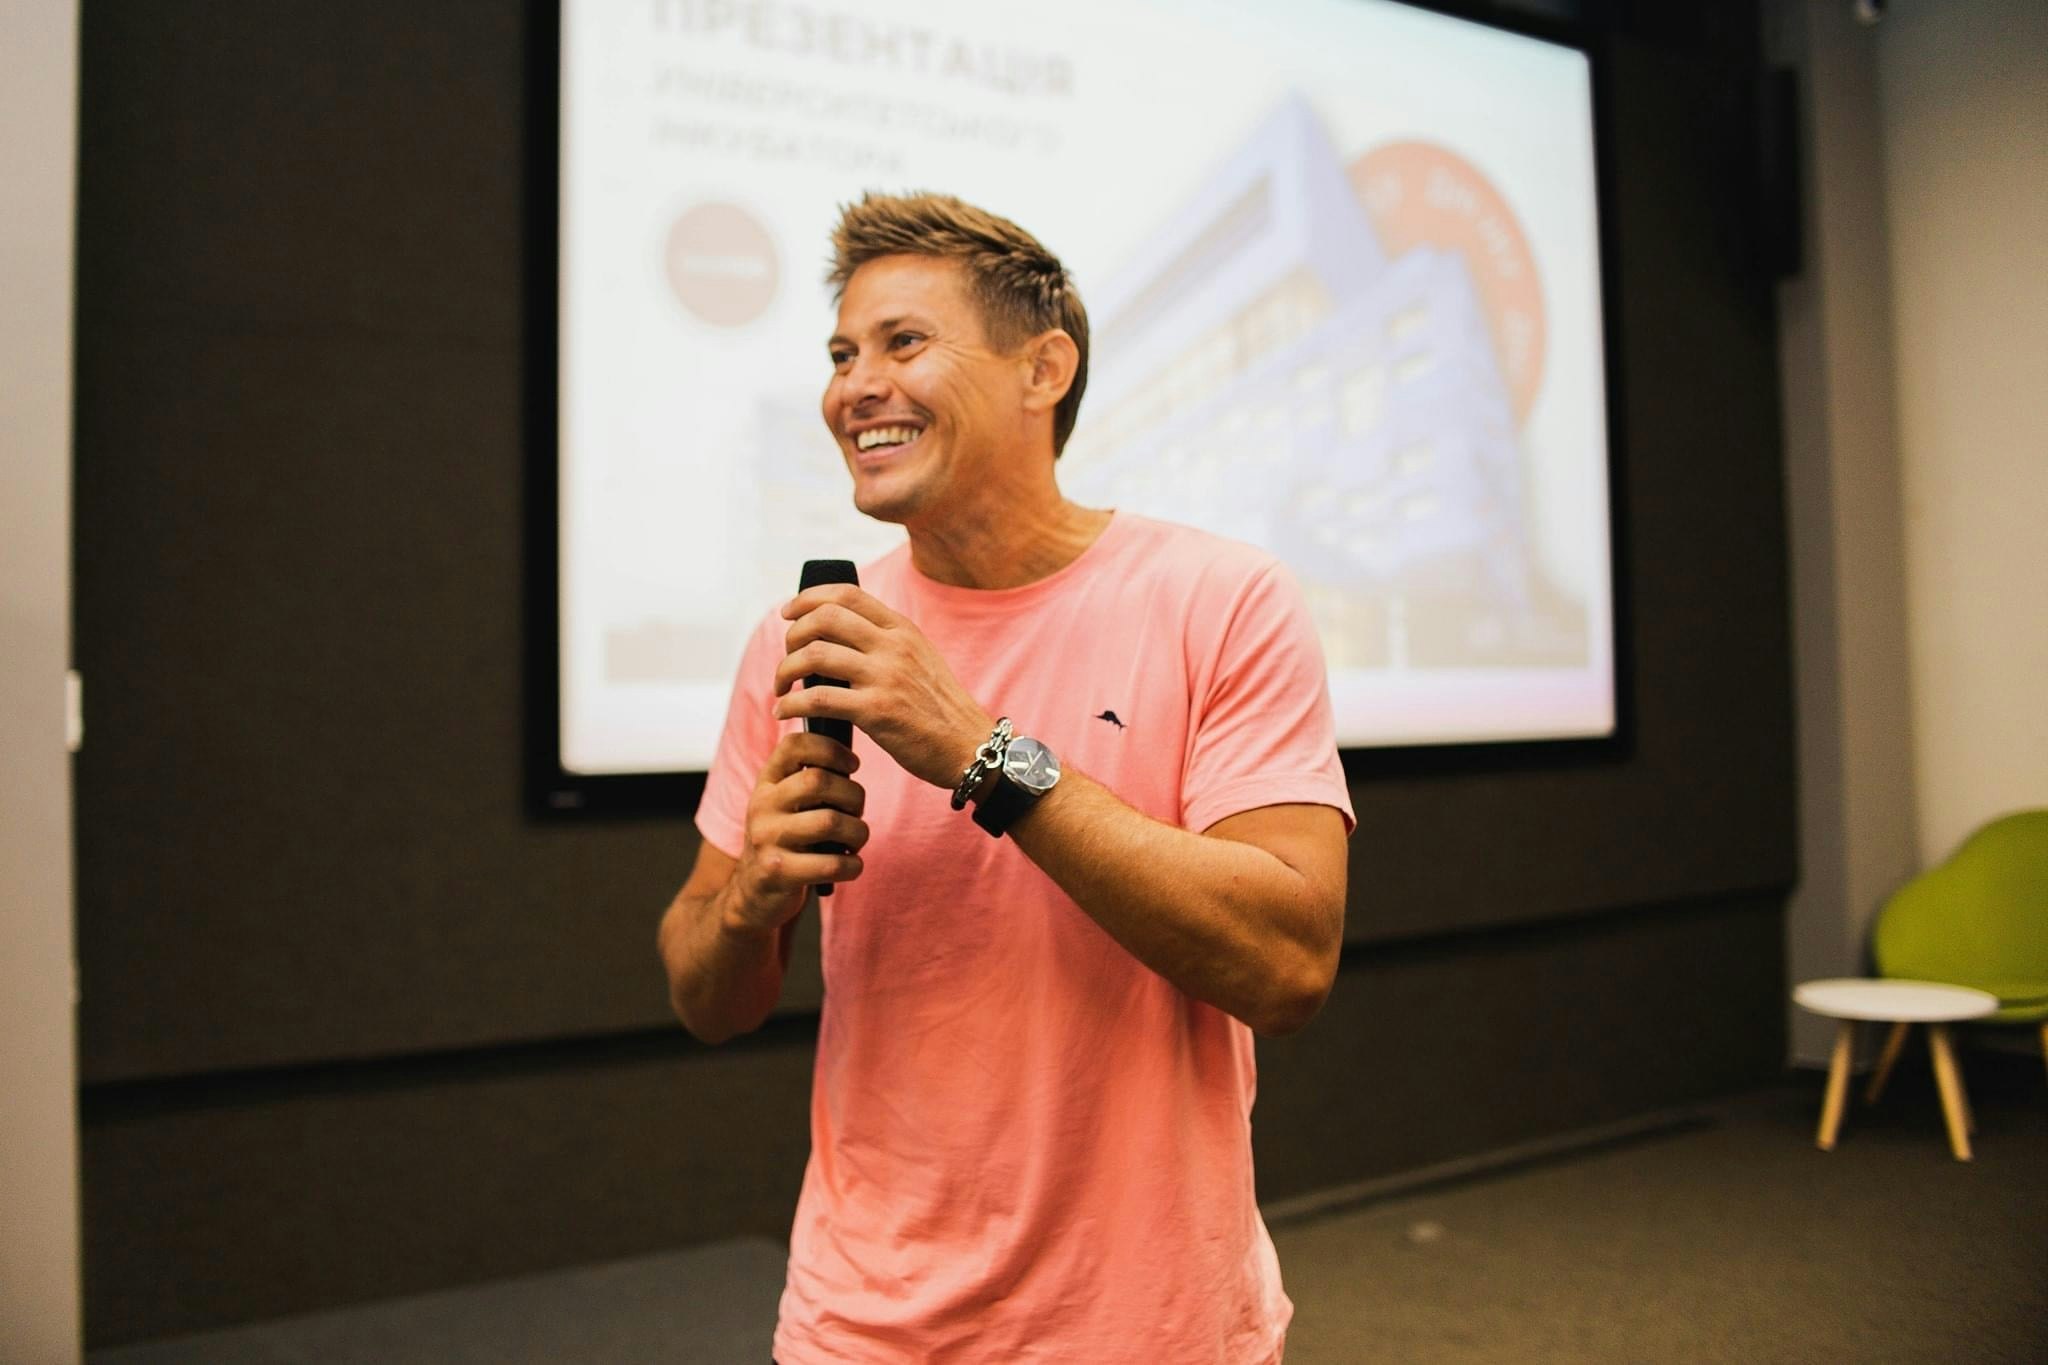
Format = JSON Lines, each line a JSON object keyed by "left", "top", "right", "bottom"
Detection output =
{"left": 76, "top": 0, "right": 1792, "bottom": 1081}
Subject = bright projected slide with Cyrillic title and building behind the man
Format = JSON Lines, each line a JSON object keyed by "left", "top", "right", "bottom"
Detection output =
{"left": 557, "top": 0, "right": 1614, "bottom": 776}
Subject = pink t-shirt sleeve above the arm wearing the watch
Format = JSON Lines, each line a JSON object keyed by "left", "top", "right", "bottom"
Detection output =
{"left": 1182, "top": 563, "right": 1358, "bottom": 833}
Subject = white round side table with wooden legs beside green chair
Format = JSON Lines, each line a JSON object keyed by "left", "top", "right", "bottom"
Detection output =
{"left": 1792, "top": 976, "right": 1999, "bottom": 1160}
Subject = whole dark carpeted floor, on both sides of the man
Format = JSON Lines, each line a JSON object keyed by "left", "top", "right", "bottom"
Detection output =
{"left": 90, "top": 1052, "right": 2048, "bottom": 1365}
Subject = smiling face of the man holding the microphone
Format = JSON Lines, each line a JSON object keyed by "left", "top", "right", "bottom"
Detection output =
{"left": 823, "top": 256, "right": 1026, "bottom": 524}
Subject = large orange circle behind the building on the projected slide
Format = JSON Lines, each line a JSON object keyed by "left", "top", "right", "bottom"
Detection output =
{"left": 1352, "top": 141, "right": 1544, "bottom": 420}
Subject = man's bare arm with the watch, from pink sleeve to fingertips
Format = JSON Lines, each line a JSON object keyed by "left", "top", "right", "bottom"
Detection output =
{"left": 776, "top": 585, "right": 1346, "bottom": 1033}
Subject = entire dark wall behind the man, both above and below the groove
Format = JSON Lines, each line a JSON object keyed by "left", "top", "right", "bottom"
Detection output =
{"left": 76, "top": 0, "right": 1794, "bottom": 1342}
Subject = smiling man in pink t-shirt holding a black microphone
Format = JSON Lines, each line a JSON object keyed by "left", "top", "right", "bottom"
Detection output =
{"left": 659, "top": 194, "right": 1352, "bottom": 1365}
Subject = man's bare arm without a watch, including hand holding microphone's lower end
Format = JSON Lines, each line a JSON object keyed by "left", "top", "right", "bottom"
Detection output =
{"left": 655, "top": 735, "right": 868, "bottom": 1044}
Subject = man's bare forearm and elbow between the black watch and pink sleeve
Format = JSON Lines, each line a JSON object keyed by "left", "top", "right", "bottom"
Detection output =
{"left": 1010, "top": 767, "right": 1343, "bottom": 1033}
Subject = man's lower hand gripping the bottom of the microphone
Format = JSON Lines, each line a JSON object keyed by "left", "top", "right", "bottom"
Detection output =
{"left": 725, "top": 733, "right": 868, "bottom": 933}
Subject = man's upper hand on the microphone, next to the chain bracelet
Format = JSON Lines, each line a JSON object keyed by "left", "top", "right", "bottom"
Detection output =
{"left": 774, "top": 583, "right": 995, "bottom": 788}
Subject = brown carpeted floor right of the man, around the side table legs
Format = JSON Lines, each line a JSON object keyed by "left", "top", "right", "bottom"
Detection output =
{"left": 1274, "top": 1052, "right": 2048, "bottom": 1365}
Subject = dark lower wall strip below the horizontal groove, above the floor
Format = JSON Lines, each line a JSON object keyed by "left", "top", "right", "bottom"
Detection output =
{"left": 82, "top": 894, "right": 1784, "bottom": 1355}
